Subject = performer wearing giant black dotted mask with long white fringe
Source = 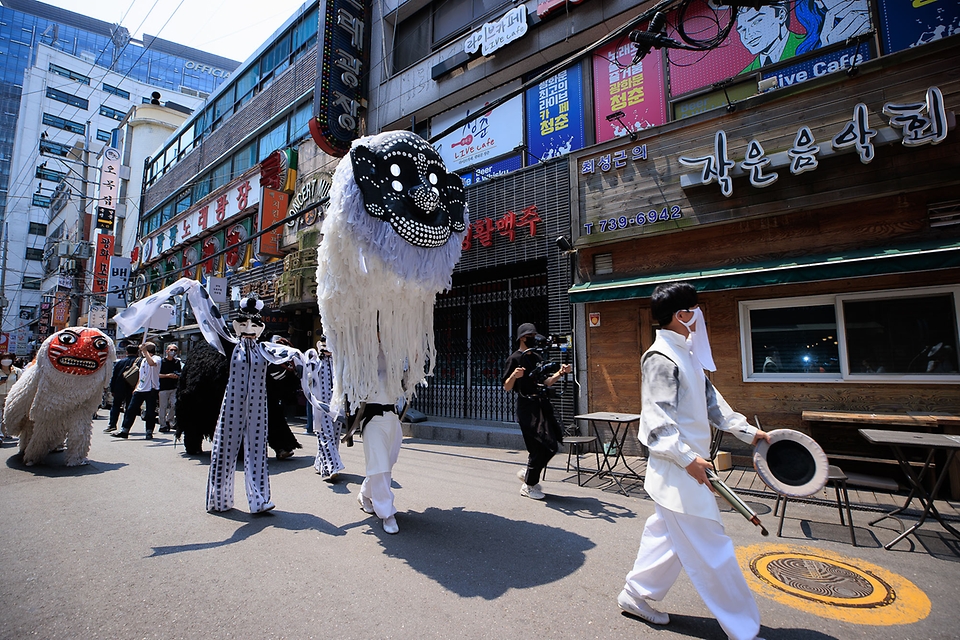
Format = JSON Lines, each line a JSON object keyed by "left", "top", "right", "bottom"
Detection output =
{"left": 317, "top": 131, "right": 466, "bottom": 533}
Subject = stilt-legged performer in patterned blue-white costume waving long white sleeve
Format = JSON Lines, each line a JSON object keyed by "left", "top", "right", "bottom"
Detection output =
{"left": 115, "top": 278, "right": 299, "bottom": 513}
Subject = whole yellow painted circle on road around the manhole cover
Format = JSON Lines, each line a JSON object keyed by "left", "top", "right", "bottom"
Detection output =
{"left": 737, "top": 544, "right": 930, "bottom": 626}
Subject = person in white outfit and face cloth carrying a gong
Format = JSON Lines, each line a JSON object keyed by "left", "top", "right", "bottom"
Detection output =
{"left": 617, "top": 283, "right": 768, "bottom": 640}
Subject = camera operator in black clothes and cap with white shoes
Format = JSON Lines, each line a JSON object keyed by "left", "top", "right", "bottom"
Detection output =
{"left": 501, "top": 322, "right": 573, "bottom": 500}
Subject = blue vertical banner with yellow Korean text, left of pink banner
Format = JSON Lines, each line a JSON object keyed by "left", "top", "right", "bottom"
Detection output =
{"left": 526, "top": 65, "right": 585, "bottom": 164}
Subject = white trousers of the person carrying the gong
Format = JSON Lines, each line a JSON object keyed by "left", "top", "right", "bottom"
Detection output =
{"left": 624, "top": 505, "right": 760, "bottom": 640}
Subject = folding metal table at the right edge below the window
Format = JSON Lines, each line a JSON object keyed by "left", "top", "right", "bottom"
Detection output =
{"left": 859, "top": 429, "right": 960, "bottom": 549}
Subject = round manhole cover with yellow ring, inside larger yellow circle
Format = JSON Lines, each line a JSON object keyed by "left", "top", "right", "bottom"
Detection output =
{"left": 750, "top": 552, "right": 896, "bottom": 608}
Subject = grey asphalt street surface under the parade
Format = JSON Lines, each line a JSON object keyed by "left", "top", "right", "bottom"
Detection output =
{"left": 0, "top": 418, "right": 960, "bottom": 640}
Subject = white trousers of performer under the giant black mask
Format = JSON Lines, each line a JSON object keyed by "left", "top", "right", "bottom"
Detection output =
{"left": 360, "top": 413, "right": 403, "bottom": 518}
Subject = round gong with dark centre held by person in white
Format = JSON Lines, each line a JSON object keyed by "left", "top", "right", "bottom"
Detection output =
{"left": 753, "top": 429, "right": 829, "bottom": 498}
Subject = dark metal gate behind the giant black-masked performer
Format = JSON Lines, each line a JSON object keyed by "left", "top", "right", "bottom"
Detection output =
{"left": 413, "top": 273, "right": 548, "bottom": 422}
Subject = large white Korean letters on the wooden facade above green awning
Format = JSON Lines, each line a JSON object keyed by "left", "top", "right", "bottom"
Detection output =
{"left": 678, "top": 87, "right": 950, "bottom": 198}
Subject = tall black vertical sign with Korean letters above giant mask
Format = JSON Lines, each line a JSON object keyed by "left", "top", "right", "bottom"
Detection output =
{"left": 310, "top": 0, "right": 370, "bottom": 158}
